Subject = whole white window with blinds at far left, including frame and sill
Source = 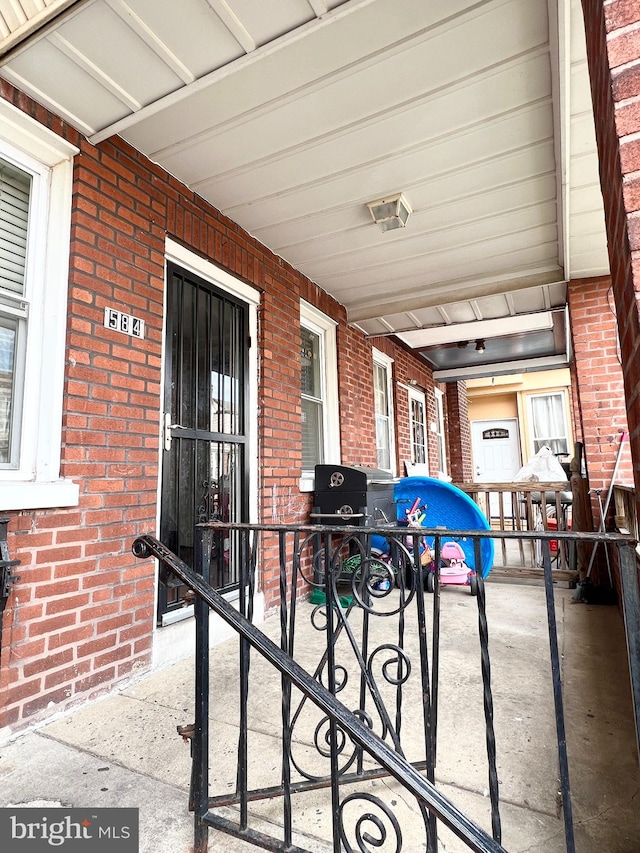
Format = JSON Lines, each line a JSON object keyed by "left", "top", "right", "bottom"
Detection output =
{"left": 0, "top": 101, "right": 78, "bottom": 510}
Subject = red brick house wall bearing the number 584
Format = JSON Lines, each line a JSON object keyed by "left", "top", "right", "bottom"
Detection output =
{"left": 0, "top": 81, "right": 440, "bottom": 728}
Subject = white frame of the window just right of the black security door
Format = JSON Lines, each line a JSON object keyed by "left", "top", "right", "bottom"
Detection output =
{"left": 300, "top": 299, "right": 340, "bottom": 492}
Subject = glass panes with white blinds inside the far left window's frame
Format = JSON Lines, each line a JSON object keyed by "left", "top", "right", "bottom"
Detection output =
{"left": 0, "top": 160, "right": 31, "bottom": 466}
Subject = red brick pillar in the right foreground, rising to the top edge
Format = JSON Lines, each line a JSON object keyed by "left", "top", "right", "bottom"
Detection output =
{"left": 582, "top": 0, "right": 640, "bottom": 506}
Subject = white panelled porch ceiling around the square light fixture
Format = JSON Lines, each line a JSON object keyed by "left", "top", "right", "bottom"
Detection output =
{"left": 0, "top": 0, "right": 608, "bottom": 376}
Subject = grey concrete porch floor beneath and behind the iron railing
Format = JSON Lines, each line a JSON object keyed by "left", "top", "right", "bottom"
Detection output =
{"left": 0, "top": 582, "right": 640, "bottom": 853}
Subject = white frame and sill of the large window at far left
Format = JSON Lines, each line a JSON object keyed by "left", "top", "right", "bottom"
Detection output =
{"left": 0, "top": 99, "right": 79, "bottom": 510}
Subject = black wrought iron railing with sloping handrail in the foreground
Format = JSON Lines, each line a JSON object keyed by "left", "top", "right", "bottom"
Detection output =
{"left": 133, "top": 523, "right": 640, "bottom": 853}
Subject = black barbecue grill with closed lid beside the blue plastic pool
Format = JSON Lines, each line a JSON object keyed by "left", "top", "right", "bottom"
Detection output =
{"left": 311, "top": 465, "right": 397, "bottom": 527}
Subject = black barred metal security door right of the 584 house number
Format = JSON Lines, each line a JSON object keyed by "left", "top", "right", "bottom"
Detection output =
{"left": 158, "top": 264, "right": 249, "bottom": 623}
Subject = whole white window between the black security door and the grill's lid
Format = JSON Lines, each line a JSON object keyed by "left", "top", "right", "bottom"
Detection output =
{"left": 300, "top": 301, "right": 340, "bottom": 491}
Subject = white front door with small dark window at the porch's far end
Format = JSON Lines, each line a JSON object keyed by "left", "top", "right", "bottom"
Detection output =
{"left": 471, "top": 418, "right": 521, "bottom": 516}
